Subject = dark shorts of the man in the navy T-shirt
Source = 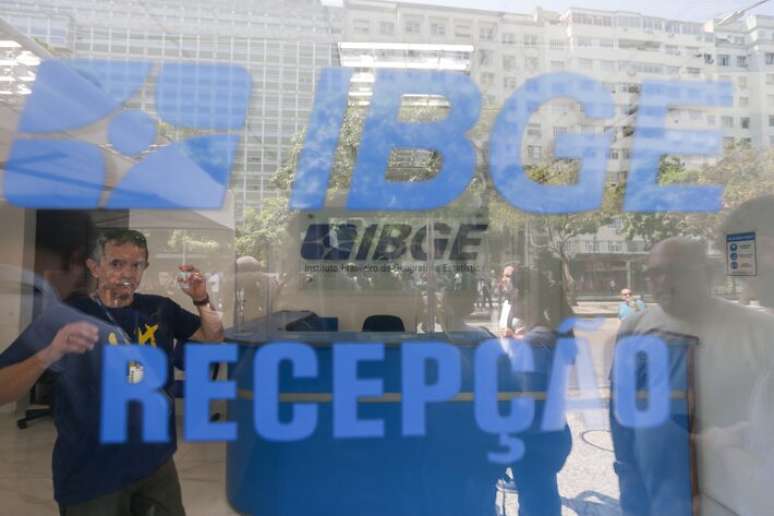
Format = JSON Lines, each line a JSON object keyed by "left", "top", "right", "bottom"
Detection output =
{"left": 59, "top": 459, "right": 185, "bottom": 516}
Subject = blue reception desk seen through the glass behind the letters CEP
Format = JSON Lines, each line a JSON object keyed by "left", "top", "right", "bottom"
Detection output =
{"left": 227, "top": 318, "right": 505, "bottom": 516}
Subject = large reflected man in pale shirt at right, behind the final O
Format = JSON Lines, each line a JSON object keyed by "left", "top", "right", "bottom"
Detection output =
{"left": 611, "top": 238, "right": 774, "bottom": 515}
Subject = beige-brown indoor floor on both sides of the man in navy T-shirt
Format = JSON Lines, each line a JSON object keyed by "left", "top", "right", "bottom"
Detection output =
{"left": 0, "top": 413, "right": 237, "bottom": 516}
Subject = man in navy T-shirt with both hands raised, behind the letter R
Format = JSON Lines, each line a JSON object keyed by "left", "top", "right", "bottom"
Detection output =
{"left": 0, "top": 230, "right": 223, "bottom": 516}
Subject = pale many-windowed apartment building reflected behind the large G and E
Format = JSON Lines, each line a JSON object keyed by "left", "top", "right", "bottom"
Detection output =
{"left": 340, "top": 0, "right": 774, "bottom": 292}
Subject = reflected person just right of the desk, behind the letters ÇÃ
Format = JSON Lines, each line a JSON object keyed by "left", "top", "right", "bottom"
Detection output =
{"left": 510, "top": 268, "right": 572, "bottom": 516}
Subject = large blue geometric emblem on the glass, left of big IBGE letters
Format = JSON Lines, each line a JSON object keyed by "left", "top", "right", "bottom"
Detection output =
{"left": 5, "top": 60, "right": 251, "bottom": 209}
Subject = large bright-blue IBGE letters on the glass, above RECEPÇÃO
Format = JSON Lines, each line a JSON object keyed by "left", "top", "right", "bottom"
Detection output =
{"left": 290, "top": 68, "right": 732, "bottom": 214}
